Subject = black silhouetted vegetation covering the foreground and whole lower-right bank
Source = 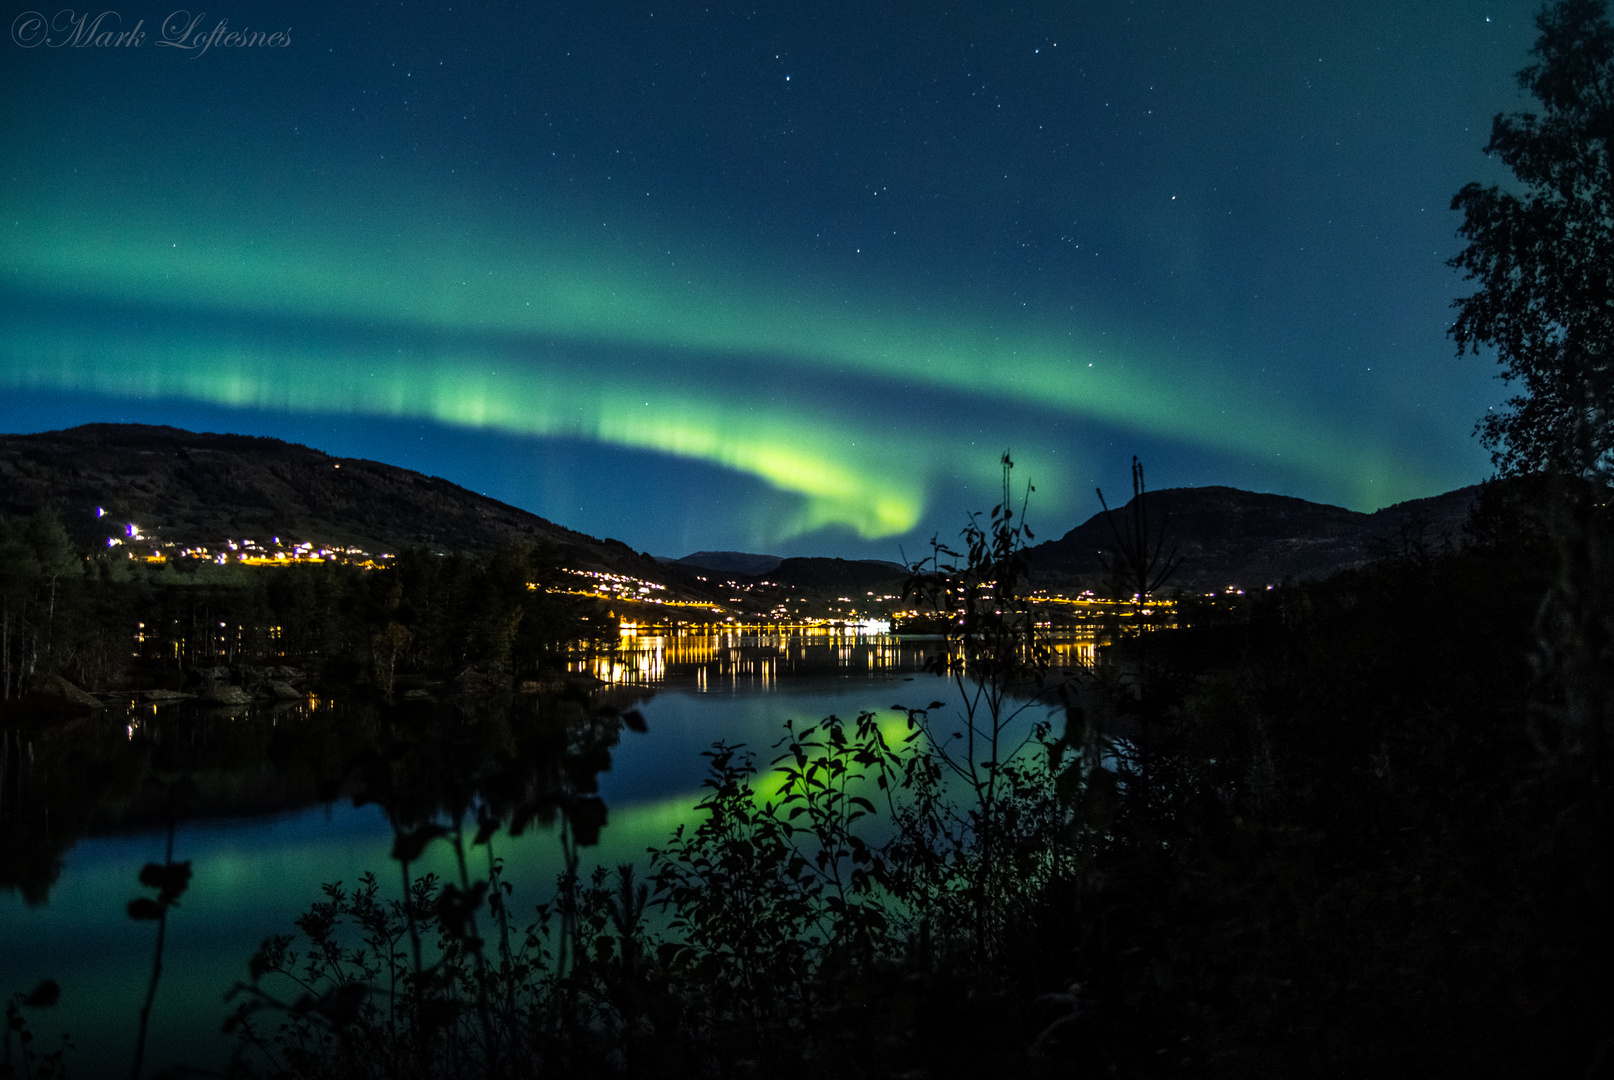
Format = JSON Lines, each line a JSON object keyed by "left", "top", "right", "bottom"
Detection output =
{"left": 8, "top": 464, "right": 1614, "bottom": 1077}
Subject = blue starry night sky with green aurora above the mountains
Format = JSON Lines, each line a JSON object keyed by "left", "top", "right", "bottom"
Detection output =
{"left": 0, "top": 0, "right": 1537, "bottom": 559}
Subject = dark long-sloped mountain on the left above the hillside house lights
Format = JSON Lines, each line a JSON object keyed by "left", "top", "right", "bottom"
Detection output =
{"left": 0, "top": 425, "right": 657, "bottom": 576}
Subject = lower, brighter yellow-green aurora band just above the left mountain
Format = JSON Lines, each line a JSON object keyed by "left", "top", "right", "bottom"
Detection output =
{"left": 0, "top": 316, "right": 936, "bottom": 538}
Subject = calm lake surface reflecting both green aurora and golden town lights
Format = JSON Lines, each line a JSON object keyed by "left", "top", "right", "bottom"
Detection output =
{"left": 0, "top": 634, "right": 1086, "bottom": 1075}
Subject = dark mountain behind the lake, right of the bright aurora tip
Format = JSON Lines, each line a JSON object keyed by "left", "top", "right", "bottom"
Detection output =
{"left": 1027, "top": 486, "right": 1480, "bottom": 589}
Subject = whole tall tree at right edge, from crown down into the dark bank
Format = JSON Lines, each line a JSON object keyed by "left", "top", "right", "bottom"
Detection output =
{"left": 1451, "top": 0, "right": 1614, "bottom": 851}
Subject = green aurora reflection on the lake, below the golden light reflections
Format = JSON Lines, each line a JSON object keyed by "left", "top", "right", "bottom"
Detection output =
{"left": 0, "top": 678, "right": 931, "bottom": 1075}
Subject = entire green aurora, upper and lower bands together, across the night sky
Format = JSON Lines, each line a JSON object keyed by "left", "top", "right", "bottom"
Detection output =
{"left": 0, "top": 176, "right": 1428, "bottom": 538}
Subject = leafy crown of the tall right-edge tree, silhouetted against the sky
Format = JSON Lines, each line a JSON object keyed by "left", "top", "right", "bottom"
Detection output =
{"left": 1449, "top": 0, "right": 1614, "bottom": 476}
